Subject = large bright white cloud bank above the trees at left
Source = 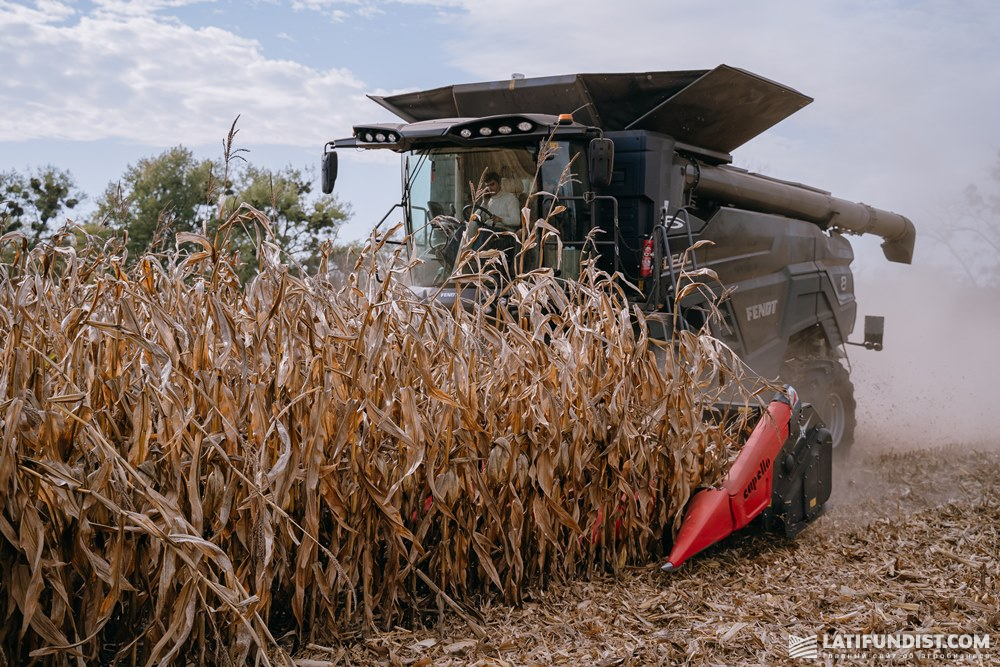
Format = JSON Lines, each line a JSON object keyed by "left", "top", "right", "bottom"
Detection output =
{"left": 0, "top": 1, "right": 372, "bottom": 146}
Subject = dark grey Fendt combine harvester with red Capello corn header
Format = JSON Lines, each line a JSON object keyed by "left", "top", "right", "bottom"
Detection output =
{"left": 323, "top": 65, "right": 916, "bottom": 570}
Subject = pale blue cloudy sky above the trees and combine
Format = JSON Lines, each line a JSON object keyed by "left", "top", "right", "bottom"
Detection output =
{"left": 0, "top": 0, "right": 1000, "bottom": 250}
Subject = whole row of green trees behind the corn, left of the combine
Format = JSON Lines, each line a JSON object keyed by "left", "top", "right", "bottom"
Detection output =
{"left": 0, "top": 146, "right": 351, "bottom": 280}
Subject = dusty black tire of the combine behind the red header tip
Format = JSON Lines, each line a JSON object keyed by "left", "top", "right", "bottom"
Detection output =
{"left": 784, "top": 359, "right": 857, "bottom": 458}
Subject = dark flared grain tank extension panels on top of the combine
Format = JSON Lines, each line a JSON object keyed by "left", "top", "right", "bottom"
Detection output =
{"left": 371, "top": 65, "right": 812, "bottom": 153}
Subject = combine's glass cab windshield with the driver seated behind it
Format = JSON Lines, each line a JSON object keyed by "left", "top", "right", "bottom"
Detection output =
{"left": 405, "top": 141, "right": 590, "bottom": 286}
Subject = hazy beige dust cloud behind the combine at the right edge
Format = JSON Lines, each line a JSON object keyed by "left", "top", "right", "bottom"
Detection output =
{"left": 848, "top": 265, "right": 1000, "bottom": 452}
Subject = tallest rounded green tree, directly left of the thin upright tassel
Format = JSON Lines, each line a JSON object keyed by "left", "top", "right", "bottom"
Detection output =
{"left": 95, "top": 146, "right": 221, "bottom": 259}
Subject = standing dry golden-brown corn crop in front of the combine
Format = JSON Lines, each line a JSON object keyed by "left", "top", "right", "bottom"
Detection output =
{"left": 0, "top": 208, "right": 752, "bottom": 665}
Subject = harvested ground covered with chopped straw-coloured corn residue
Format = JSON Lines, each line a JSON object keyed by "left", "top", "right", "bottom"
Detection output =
{"left": 297, "top": 433, "right": 1000, "bottom": 667}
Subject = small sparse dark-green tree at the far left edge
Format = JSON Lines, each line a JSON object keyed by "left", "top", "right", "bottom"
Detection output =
{"left": 0, "top": 165, "right": 85, "bottom": 244}
